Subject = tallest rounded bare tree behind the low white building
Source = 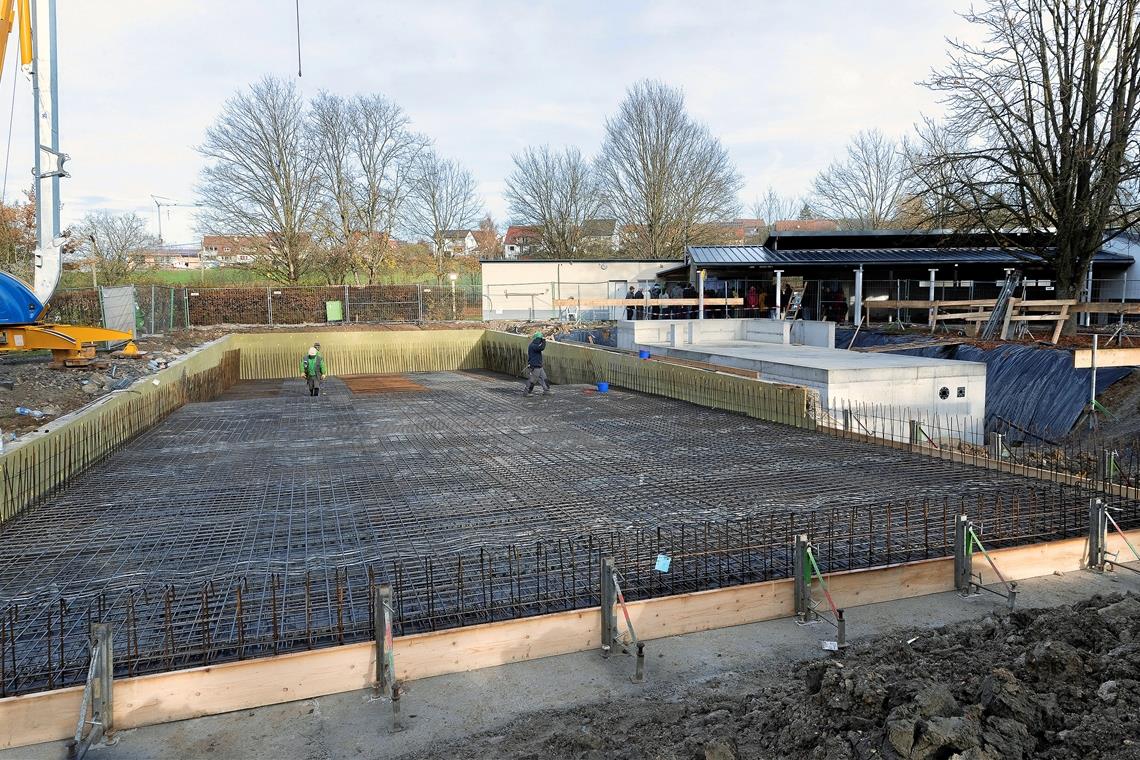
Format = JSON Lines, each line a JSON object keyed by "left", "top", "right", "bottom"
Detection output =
{"left": 597, "top": 81, "right": 741, "bottom": 259}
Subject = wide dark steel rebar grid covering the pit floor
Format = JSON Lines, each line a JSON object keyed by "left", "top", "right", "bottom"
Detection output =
{"left": 0, "top": 374, "right": 1140, "bottom": 694}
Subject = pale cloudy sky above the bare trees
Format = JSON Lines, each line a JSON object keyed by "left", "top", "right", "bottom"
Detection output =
{"left": 0, "top": 0, "right": 968, "bottom": 243}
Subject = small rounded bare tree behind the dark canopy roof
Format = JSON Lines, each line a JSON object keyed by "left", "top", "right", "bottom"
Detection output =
{"left": 812, "top": 130, "right": 910, "bottom": 229}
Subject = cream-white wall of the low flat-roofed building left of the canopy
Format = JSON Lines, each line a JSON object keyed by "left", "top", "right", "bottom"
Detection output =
{"left": 482, "top": 261, "right": 681, "bottom": 320}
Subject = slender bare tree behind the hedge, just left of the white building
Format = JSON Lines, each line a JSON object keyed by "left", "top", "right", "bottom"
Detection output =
{"left": 408, "top": 150, "right": 482, "bottom": 283}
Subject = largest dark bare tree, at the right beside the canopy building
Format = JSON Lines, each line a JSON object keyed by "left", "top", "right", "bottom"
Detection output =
{"left": 914, "top": 0, "right": 1140, "bottom": 297}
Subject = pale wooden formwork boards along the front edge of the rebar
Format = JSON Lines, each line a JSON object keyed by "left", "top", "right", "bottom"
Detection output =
{"left": 0, "top": 530, "right": 1140, "bottom": 749}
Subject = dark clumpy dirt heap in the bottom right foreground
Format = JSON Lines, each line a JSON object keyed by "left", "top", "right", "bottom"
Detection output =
{"left": 417, "top": 595, "right": 1140, "bottom": 760}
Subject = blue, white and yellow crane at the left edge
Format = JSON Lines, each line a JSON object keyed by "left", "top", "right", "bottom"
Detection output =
{"left": 0, "top": 0, "right": 138, "bottom": 367}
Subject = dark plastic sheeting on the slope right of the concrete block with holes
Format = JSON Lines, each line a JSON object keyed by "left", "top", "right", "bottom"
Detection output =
{"left": 836, "top": 328, "right": 1132, "bottom": 438}
